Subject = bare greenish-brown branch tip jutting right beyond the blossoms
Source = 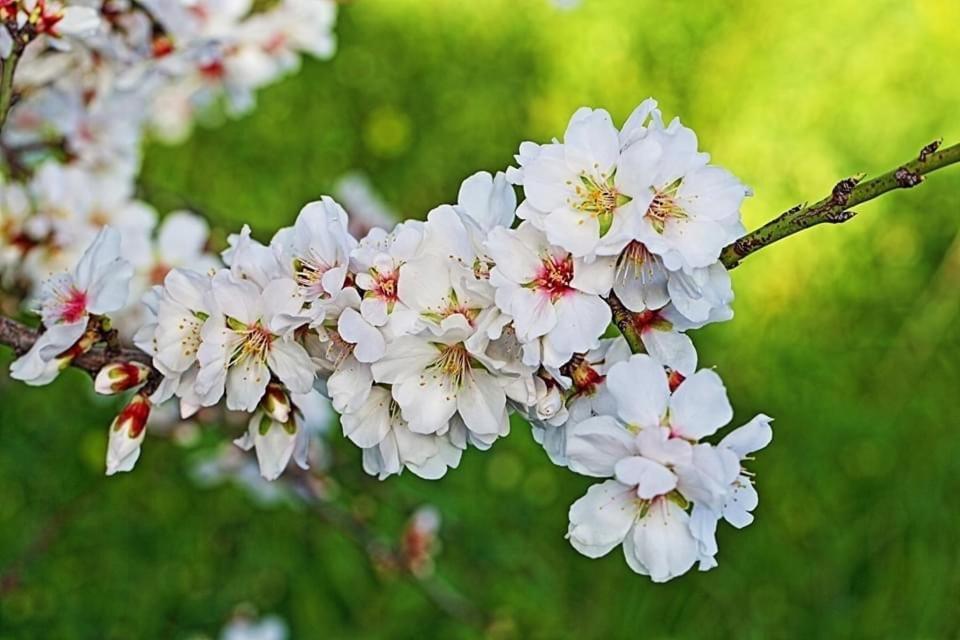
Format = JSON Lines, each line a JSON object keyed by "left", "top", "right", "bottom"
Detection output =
{"left": 720, "top": 141, "right": 960, "bottom": 269}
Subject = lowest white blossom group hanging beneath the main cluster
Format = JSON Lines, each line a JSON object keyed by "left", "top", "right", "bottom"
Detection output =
{"left": 567, "top": 355, "right": 769, "bottom": 582}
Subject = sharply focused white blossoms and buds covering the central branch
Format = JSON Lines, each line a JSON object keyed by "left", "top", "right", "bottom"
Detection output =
{"left": 5, "top": 100, "right": 771, "bottom": 581}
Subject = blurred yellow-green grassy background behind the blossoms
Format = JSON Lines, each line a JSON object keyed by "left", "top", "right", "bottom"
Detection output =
{"left": 0, "top": 0, "right": 960, "bottom": 639}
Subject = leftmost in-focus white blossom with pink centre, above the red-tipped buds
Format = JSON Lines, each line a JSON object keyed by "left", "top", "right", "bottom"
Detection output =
{"left": 10, "top": 227, "right": 133, "bottom": 385}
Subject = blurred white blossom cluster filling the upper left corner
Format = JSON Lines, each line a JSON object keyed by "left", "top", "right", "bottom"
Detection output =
{"left": 0, "top": 0, "right": 336, "bottom": 338}
